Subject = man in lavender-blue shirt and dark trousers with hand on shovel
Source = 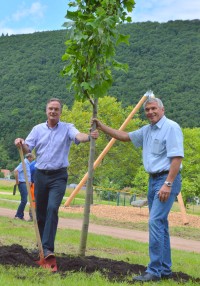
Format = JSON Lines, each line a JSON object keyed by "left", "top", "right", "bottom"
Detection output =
{"left": 15, "top": 98, "right": 98, "bottom": 258}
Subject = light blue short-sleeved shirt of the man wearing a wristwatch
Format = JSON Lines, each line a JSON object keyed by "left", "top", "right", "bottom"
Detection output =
{"left": 129, "top": 116, "right": 184, "bottom": 173}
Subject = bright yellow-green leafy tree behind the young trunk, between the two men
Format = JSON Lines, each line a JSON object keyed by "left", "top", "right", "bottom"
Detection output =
{"left": 61, "top": 96, "right": 145, "bottom": 189}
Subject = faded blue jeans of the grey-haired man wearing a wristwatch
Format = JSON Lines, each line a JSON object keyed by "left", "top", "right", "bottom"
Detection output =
{"left": 146, "top": 174, "right": 181, "bottom": 277}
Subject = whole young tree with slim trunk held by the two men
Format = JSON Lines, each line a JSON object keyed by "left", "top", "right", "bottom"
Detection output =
{"left": 62, "top": 0, "right": 135, "bottom": 256}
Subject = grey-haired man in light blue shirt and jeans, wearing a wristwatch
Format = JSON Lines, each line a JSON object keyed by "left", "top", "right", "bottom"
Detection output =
{"left": 93, "top": 97, "right": 184, "bottom": 282}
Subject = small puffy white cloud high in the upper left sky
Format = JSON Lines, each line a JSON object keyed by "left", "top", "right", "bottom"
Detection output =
{"left": 12, "top": 2, "right": 46, "bottom": 21}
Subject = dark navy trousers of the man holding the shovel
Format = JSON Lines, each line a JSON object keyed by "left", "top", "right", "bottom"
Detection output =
{"left": 35, "top": 169, "right": 68, "bottom": 251}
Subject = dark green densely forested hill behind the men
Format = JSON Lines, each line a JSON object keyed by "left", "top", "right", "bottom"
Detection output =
{"left": 0, "top": 20, "right": 200, "bottom": 168}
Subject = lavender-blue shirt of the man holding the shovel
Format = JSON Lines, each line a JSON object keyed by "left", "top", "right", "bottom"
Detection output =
{"left": 25, "top": 121, "right": 79, "bottom": 170}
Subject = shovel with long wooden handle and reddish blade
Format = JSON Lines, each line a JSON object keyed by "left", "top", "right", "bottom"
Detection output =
{"left": 19, "top": 146, "right": 57, "bottom": 272}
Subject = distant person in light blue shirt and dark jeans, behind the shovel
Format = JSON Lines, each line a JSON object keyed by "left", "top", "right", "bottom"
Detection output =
{"left": 14, "top": 153, "right": 33, "bottom": 220}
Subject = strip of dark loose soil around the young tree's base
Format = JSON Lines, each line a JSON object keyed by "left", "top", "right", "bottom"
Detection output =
{"left": 0, "top": 244, "right": 200, "bottom": 284}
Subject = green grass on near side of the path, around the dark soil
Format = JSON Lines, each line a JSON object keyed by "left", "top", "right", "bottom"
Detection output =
{"left": 0, "top": 217, "right": 200, "bottom": 286}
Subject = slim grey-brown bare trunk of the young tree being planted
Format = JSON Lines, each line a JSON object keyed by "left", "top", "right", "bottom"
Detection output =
{"left": 79, "top": 99, "right": 98, "bottom": 256}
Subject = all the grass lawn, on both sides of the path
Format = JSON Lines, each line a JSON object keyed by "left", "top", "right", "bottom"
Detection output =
{"left": 0, "top": 181, "right": 200, "bottom": 286}
